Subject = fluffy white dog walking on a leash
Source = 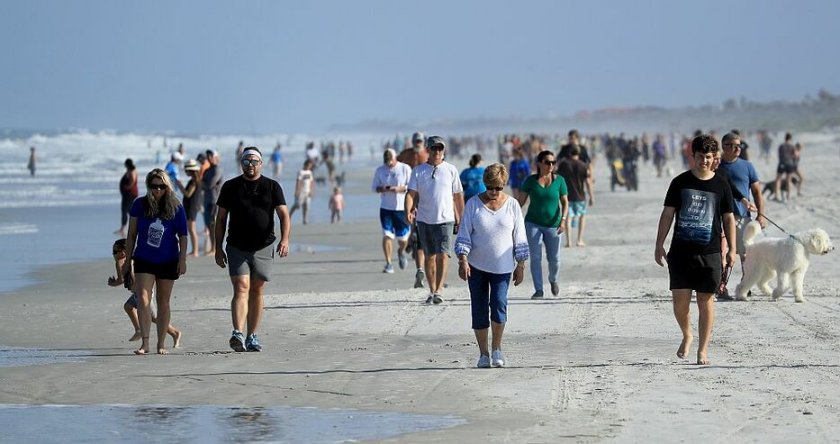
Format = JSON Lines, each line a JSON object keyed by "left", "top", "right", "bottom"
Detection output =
{"left": 735, "top": 221, "right": 834, "bottom": 302}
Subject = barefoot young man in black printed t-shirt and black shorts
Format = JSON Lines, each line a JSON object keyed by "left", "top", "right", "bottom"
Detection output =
{"left": 655, "top": 134, "right": 735, "bottom": 365}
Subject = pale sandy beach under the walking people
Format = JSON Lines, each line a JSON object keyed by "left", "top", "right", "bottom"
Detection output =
{"left": 0, "top": 134, "right": 840, "bottom": 443}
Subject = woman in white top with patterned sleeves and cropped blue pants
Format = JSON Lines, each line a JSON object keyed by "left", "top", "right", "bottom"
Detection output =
{"left": 455, "top": 163, "right": 529, "bottom": 368}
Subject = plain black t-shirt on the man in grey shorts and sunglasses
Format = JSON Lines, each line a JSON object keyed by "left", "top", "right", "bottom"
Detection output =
{"left": 216, "top": 175, "right": 286, "bottom": 251}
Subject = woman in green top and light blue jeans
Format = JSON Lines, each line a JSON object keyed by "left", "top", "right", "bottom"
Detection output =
{"left": 517, "top": 151, "right": 569, "bottom": 299}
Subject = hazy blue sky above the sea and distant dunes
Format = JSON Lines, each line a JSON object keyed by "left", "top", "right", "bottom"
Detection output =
{"left": 0, "top": 0, "right": 840, "bottom": 133}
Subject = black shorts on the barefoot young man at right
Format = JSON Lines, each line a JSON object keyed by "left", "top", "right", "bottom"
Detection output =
{"left": 668, "top": 251, "right": 723, "bottom": 293}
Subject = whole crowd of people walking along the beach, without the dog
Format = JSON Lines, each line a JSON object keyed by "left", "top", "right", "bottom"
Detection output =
{"left": 109, "top": 130, "right": 802, "bottom": 367}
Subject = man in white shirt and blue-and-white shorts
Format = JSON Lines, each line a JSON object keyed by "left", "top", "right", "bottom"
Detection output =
{"left": 371, "top": 148, "right": 411, "bottom": 273}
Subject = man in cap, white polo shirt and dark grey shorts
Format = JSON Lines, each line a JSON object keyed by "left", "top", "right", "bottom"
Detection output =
{"left": 405, "top": 136, "right": 464, "bottom": 304}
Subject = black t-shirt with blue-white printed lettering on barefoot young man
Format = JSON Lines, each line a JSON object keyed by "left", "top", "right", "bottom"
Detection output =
{"left": 665, "top": 171, "right": 732, "bottom": 255}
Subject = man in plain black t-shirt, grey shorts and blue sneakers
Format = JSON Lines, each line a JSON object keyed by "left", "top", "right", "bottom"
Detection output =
{"left": 216, "top": 147, "right": 291, "bottom": 352}
